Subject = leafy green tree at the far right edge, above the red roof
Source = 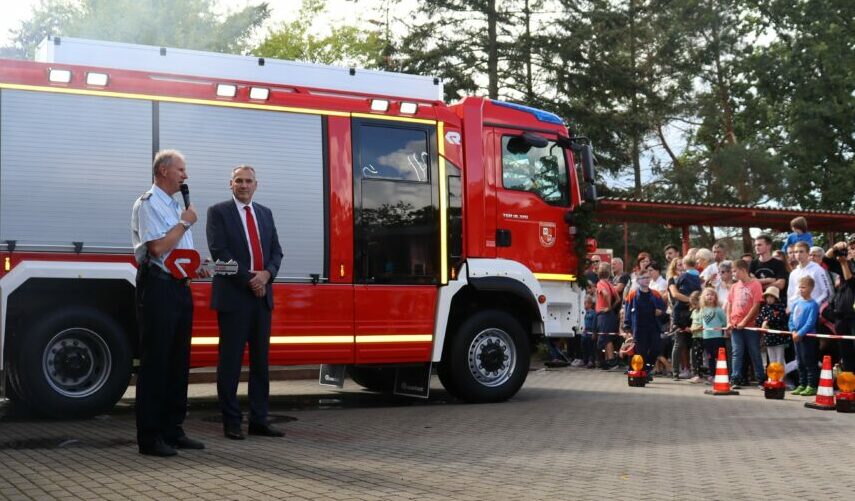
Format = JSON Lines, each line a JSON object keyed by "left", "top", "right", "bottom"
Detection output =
{"left": 750, "top": 0, "right": 855, "bottom": 210}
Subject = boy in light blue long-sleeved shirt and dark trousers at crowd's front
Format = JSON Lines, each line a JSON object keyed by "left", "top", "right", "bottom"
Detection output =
{"left": 790, "top": 277, "right": 819, "bottom": 397}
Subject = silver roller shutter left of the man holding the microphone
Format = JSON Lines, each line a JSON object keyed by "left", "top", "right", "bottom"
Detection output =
{"left": 0, "top": 90, "right": 151, "bottom": 252}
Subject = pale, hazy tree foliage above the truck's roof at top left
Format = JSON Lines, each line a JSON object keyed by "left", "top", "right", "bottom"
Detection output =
{"left": 5, "top": 0, "right": 270, "bottom": 58}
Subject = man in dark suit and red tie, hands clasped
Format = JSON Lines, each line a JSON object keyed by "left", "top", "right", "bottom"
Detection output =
{"left": 207, "top": 165, "right": 284, "bottom": 440}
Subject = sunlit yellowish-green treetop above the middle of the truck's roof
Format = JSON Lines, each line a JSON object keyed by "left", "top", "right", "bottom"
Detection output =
{"left": 253, "top": 0, "right": 386, "bottom": 68}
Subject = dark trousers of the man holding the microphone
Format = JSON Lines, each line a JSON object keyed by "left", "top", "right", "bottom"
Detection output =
{"left": 136, "top": 275, "right": 193, "bottom": 445}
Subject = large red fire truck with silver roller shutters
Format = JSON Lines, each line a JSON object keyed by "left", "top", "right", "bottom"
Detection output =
{"left": 0, "top": 38, "right": 595, "bottom": 416}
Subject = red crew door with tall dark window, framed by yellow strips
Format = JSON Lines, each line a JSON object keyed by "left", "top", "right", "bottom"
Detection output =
{"left": 353, "top": 119, "right": 440, "bottom": 364}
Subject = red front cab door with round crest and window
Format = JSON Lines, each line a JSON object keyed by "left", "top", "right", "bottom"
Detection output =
{"left": 491, "top": 128, "right": 573, "bottom": 275}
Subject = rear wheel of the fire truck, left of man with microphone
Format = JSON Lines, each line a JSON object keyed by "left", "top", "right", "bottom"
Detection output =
{"left": 16, "top": 307, "right": 132, "bottom": 418}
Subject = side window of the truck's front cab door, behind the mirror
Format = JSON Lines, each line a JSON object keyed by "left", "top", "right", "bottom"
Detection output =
{"left": 502, "top": 136, "right": 570, "bottom": 207}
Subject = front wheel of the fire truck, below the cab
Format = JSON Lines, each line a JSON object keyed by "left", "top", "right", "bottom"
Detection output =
{"left": 437, "top": 310, "right": 530, "bottom": 403}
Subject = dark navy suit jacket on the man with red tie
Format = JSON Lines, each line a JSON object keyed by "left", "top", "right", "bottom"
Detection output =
{"left": 206, "top": 199, "right": 283, "bottom": 311}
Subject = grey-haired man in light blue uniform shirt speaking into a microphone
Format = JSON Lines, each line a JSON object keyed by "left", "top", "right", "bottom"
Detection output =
{"left": 131, "top": 150, "right": 205, "bottom": 457}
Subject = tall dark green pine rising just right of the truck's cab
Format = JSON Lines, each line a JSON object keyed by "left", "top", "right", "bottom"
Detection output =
{"left": 544, "top": 0, "right": 692, "bottom": 196}
